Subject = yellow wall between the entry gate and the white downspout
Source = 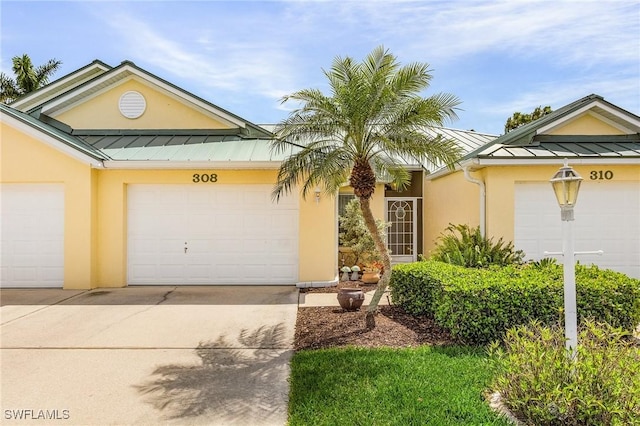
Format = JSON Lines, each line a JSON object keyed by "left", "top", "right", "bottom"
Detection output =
{"left": 422, "top": 171, "right": 483, "bottom": 257}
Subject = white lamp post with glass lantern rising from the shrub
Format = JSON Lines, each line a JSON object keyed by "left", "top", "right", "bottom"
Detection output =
{"left": 550, "top": 159, "right": 582, "bottom": 358}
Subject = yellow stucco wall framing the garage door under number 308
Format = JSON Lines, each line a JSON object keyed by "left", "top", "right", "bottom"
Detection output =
{"left": 97, "top": 170, "right": 337, "bottom": 287}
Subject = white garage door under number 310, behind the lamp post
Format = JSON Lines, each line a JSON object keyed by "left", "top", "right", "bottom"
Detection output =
{"left": 514, "top": 180, "right": 640, "bottom": 278}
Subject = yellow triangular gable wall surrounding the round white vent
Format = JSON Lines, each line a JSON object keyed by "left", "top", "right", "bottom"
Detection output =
{"left": 53, "top": 78, "right": 235, "bottom": 129}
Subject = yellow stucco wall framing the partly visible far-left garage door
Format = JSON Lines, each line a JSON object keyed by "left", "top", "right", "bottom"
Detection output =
{"left": 0, "top": 122, "right": 96, "bottom": 289}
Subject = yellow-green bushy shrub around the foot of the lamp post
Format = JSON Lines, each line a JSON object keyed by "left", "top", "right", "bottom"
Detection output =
{"left": 489, "top": 321, "right": 640, "bottom": 425}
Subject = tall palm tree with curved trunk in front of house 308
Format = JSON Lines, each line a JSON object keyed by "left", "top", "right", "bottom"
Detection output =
{"left": 272, "top": 46, "right": 460, "bottom": 328}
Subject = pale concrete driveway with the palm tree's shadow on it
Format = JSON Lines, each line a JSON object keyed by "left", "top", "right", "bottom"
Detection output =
{"left": 0, "top": 286, "right": 298, "bottom": 425}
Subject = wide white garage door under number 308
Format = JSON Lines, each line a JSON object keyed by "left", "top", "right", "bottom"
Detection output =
{"left": 127, "top": 184, "right": 298, "bottom": 285}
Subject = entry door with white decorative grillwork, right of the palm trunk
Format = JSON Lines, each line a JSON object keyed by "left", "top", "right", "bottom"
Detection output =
{"left": 386, "top": 198, "right": 418, "bottom": 263}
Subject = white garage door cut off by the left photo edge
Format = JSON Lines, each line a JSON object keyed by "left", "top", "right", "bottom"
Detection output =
{"left": 0, "top": 184, "right": 64, "bottom": 288}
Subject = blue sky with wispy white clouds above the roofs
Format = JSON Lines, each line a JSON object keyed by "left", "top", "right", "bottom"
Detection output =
{"left": 0, "top": 0, "right": 640, "bottom": 134}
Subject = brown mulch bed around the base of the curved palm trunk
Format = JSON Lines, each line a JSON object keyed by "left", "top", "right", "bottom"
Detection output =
{"left": 294, "top": 281, "right": 455, "bottom": 351}
